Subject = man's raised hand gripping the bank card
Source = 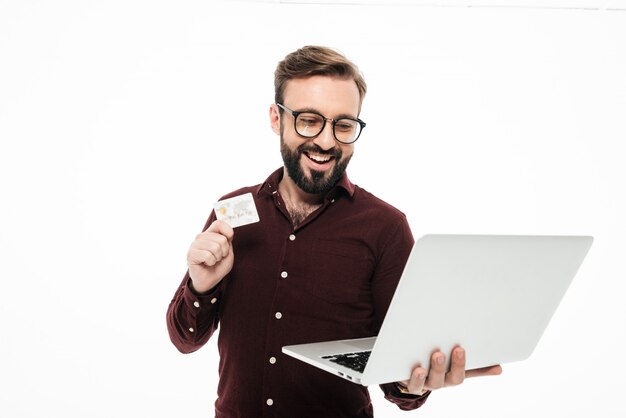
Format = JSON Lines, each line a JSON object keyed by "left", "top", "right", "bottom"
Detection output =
{"left": 187, "top": 220, "right": 235, "bottom": 293}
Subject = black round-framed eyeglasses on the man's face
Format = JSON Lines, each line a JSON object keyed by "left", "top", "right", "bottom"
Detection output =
{"left": 276, "top": 103, "right": 365, "bottom": 144}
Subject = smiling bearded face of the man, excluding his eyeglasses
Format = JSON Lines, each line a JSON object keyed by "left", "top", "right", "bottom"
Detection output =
{"left": 270, "top": 76, "right": 360, "bottom": 194}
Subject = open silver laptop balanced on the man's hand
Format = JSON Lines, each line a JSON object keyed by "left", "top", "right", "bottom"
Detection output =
{"left": 282, "top": 234, "right": 593, "bottom": 386}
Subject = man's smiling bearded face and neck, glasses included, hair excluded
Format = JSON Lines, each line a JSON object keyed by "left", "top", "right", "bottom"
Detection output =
{"left": 270, "top": 75, "right": 358, "bottom": 226}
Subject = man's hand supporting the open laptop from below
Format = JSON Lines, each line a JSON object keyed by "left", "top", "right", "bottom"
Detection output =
{"left": 400, "top": 347, "right": 502, "bottom": 395}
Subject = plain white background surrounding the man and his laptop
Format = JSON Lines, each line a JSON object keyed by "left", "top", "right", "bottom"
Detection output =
{"left": 0, "top": 0, "right": 626, "bottom": 418}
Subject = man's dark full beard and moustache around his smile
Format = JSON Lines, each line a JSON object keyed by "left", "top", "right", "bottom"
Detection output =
{"left": 280, "top": 134, "right": 352, "bottom": 194}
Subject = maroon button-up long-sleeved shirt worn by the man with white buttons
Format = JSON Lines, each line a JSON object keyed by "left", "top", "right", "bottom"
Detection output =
{"left": 167, "top": 168, "right": 428, "bottom": 418}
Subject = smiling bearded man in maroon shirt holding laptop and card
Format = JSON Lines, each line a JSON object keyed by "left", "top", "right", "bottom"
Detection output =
{"left": 167, "top": 46, "right": 501, "bottom": 417}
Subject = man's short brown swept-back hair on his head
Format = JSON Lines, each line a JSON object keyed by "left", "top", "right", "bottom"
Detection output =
{"left": 274, "top": 46, "right": 367, "bottom": 108}
